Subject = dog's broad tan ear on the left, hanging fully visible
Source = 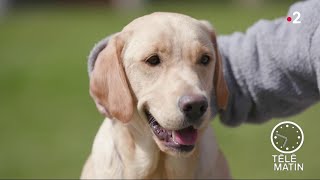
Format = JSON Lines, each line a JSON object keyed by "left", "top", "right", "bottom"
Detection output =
{"left": 88, "top": 35, "right": 133, "bottom": 123}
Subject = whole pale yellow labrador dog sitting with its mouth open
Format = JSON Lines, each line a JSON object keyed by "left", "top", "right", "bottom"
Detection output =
{"left": 81, "top": 13, "right": 230, "bottom": 179}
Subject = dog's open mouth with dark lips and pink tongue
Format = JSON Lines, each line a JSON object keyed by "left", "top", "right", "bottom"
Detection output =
{"left": 145, "top": 111, "right": 198, "bottom": 152}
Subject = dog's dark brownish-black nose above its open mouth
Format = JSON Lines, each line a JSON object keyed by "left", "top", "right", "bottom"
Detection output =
{"left": 178, "top": 95, "right": 208, "bottom": 121}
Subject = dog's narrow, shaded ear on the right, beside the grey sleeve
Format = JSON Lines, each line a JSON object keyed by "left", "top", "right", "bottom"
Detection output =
{"left": 200, "top": 20, "right": 229, "bottom": 110}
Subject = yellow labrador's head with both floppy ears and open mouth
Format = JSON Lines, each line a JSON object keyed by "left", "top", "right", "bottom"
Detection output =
{"left": 89, "top": 13, "right": 228, "bottom": 154}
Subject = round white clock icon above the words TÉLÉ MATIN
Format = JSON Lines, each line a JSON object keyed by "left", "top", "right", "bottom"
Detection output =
{"left": 270, "top": 121, "right": 304, "bottom": 154}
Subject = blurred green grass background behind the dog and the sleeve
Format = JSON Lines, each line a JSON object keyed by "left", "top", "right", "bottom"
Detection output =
{"left": 0, "top": 0, "right": 320, "bottom": 179}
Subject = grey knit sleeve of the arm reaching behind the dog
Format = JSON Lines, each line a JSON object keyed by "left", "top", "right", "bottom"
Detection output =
{"left": 218, "top": 0, "right": 320, "bottom": 126}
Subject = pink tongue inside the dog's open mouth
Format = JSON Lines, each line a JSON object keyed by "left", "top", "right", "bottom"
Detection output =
{"left": 173, "top": 127, "right": 198, "bottom": 145}
